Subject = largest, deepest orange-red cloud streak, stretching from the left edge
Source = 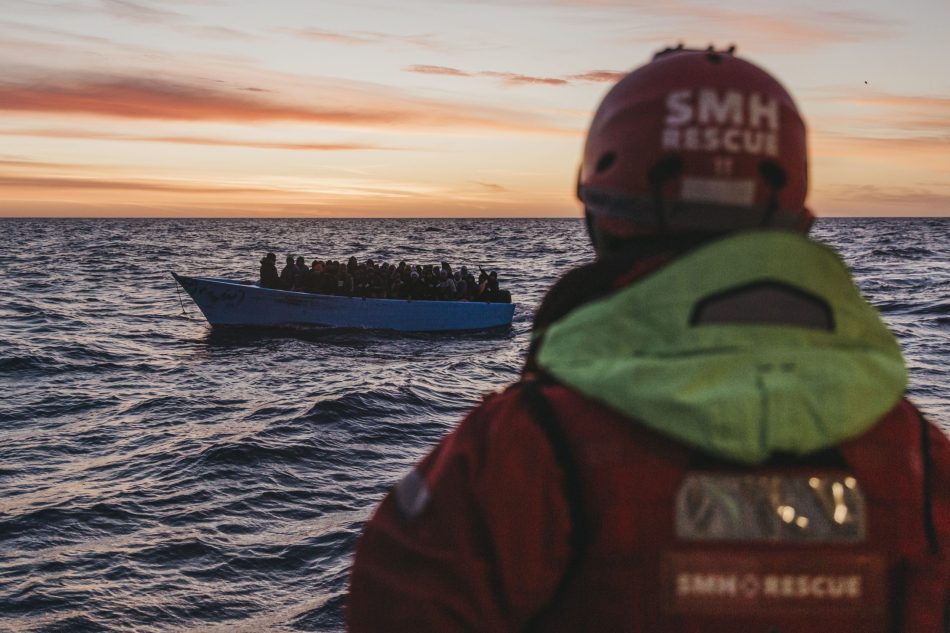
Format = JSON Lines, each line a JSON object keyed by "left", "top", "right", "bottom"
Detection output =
{"left": 0, "top": 76, "right": 573, "bottom": 133}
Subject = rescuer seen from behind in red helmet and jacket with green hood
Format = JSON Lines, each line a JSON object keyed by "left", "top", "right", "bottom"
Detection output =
{"left": 347, "top": 48, "right": 950, "bottom": 633}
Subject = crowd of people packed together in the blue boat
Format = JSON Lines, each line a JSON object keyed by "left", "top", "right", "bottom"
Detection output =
{"left": 260, "top": 253, "right": 511, "bottom": 303}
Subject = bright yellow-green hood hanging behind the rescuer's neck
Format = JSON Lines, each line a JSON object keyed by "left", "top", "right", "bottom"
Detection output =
{"left": 537, "top": 231, "right": 907, "bottom": 463}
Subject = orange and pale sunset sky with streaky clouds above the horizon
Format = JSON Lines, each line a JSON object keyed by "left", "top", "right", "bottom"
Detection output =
{"left": 0, "top": 0, "right": 950, "bottom": 217}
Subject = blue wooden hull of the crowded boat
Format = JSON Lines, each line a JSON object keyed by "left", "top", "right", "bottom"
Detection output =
{"left": 172, "top": 273, "right": 515, "bottom": 332}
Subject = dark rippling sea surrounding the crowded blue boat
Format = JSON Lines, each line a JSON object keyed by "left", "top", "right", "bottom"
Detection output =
{"left": 0, "top": 218, "right": 950, "bottom": 633}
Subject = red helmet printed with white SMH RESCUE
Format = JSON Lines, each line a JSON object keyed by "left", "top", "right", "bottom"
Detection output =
{"left": 577, "top": 46, "right": 814, "bottom": 242}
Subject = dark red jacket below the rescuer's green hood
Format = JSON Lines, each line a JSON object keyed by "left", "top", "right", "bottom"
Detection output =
{"left": 347, "top": 386, "right": 950, "bottom": 631}
